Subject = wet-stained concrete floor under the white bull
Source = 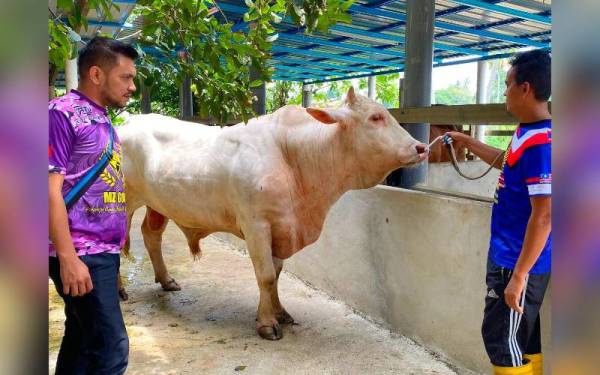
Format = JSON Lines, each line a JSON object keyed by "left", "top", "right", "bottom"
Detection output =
{"left": 49, "top": 209, "right": 463, "bottom": 375}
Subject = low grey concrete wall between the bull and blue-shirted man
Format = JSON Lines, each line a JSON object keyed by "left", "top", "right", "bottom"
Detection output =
{"left": 214, "top": 186, "right": 550, "bottom": 373}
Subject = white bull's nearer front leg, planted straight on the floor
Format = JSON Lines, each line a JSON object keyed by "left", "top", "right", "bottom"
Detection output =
{"left": 244, "top": 224, "right": 283, "bottom": 340}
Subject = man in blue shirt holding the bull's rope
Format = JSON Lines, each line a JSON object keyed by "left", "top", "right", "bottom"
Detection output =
{"left": 448, "top": 50, "right": 552, "bottom": 375}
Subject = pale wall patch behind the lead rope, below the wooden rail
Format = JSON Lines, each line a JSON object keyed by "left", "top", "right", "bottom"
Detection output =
{"left": 427, "top": 160, "right": 500, "bottom": 197}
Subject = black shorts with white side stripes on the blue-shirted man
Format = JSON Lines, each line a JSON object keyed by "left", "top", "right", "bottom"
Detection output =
{"left": 481, "top": 258, "right": 550, "bottom": 367}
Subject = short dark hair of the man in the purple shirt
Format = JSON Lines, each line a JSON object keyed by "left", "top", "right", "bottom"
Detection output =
{"left": 77, "top": 36, "right": 138, "bottom": 78}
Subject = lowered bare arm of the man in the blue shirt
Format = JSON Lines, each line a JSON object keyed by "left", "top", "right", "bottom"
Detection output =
{"left": 504, "top": 195, "right": 552, "bottom": 314}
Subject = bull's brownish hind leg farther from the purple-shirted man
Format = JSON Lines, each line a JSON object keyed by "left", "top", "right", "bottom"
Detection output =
{"left": 142, "top": 207, "right": 181, "bottom": 291}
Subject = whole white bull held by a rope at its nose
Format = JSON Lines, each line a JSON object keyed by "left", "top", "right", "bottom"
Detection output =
{"left": 119, "top": 88, "right": 427, "bottom": 340}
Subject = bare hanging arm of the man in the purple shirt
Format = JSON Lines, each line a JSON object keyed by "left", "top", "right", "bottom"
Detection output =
{"left": 48, "top": 173, "right": 93, "bottom": 297}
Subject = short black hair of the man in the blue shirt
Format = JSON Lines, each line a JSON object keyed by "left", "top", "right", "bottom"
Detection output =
{"left": 510, "top": 50, "right": 552, "bottom": 101}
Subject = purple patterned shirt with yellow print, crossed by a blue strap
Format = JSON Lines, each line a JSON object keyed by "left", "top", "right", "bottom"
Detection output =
{"left": 48, "top": 90, "right": 127, "bottom": 256}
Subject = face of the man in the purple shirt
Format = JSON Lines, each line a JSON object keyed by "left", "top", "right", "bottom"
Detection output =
{"left": 100, "top": 55, "right": 136, "bottom": 108}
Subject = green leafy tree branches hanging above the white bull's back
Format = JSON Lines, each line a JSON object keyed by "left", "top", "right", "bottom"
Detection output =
{"left": 138, "top": 0, "right": 351, "bottom": 122}
